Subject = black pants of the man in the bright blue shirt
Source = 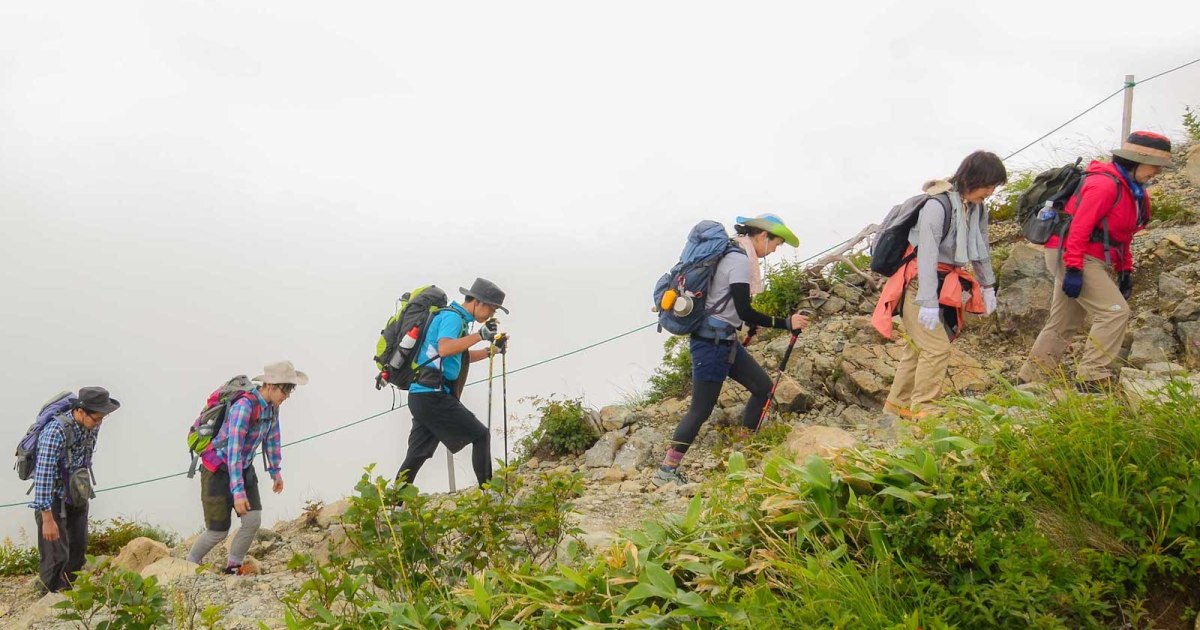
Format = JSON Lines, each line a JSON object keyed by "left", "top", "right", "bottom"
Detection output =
{"left": 396, "top": 392, "right": 492, "bottom": 486}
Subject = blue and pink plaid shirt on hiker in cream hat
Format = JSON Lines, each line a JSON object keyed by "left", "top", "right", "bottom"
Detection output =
{"left": 200, "top": 389, "right": 282, "bottom": 500}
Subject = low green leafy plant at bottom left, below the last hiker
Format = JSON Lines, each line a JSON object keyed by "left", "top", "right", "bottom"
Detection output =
{"left": 54, "top": 556, "right": 170, "bottom": 630}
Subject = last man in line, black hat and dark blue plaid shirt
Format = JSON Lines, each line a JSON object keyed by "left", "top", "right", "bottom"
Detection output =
{"left": 29, "top": 388, "right": 121, "bottom": 592}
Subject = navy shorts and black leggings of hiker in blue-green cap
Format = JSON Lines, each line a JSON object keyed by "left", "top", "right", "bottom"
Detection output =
{"left": 671, "top": 336, "right": 772, "bottom": 452}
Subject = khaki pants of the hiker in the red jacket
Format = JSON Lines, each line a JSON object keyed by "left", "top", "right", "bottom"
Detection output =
{"left": 1018, "top": 250, "right": 1129, "bottom": 382}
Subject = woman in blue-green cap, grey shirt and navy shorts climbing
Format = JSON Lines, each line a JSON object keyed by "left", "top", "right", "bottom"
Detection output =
{"left": 653, "top": 215, "right": 809, "bottom": 486}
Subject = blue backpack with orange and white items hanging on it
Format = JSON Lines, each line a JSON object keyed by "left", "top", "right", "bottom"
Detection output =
{"left": 654, "top": 221, "right": 745, "bottom": 335}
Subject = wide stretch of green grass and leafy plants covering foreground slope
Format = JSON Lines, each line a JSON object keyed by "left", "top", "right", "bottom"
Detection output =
{"left": 280, "top": 376, "right": 1200, "bottom": 629}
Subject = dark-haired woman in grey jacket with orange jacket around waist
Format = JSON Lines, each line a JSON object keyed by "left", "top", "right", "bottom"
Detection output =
{"left": 883, "top": 151, "right": 1008, "bottom": 416}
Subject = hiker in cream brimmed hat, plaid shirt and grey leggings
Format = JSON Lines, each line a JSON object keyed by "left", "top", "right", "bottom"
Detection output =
{"left": 187, "top": 361, "right": 308, "bottom": 575}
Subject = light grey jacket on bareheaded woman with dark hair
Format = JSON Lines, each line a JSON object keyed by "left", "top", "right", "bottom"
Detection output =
{"left": 908, "top": 180, "right": 996, "bottom": 306}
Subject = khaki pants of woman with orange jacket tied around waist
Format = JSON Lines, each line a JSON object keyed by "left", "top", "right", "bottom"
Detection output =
{"left": 888, "top": 280, "right": 950, "bottom": 412}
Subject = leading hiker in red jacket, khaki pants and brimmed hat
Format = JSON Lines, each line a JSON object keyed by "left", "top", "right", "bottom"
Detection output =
{"left": 1018, "top": 131, "right": 1171, "bottom": 391}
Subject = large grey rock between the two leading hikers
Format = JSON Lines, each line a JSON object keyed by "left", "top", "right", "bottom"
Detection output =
{"left": 996, "top": 242, "right": 1054, "bottom": 334}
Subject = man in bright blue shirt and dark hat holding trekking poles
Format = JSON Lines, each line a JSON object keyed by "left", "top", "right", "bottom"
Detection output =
{"left": 396, "top": 278, "right": 509, "bottom": 486}
